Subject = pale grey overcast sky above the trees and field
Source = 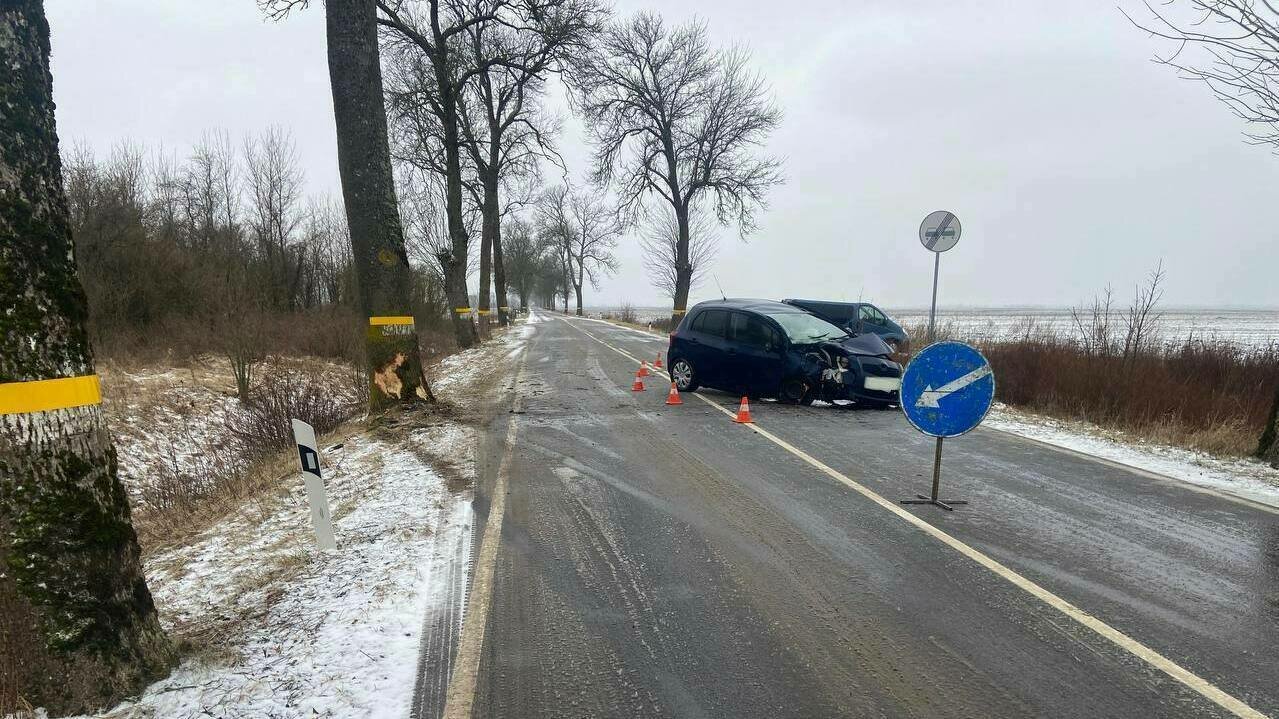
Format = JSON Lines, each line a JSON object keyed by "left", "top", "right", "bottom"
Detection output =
{"left": 46, "top": 0, "right": 1279, "bottom": 307}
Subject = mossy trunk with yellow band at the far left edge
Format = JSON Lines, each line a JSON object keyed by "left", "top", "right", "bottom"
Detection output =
{"left": 0, "top": 0, "right": 174, "bottom": 715}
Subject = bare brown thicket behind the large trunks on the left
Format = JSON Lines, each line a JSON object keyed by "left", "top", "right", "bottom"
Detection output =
{"left": 64, "top": 128, "right": 455, "bottom": 360}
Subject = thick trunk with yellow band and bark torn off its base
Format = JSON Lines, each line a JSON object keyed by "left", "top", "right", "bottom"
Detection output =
{"left": 325, "top": 0, "right": 435, "bottom": 411}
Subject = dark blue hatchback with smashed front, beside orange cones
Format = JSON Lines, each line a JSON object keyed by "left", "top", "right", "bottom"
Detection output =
{"left": 666, "top": 299, "right": 902, "bottom": 407}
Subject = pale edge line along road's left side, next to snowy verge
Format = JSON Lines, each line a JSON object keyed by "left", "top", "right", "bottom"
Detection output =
{"left": 444, "top": 363, "right": 528, "bottom": 719}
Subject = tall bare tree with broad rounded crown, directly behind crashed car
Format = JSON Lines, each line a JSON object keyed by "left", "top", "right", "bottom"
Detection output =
{"left": 569, "top": 13, "right": 783, "bottom": 321}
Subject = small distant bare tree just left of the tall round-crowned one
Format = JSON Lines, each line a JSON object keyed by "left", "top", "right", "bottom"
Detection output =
{"left": 537, "top": 184, "right": 623, "bottom": 316}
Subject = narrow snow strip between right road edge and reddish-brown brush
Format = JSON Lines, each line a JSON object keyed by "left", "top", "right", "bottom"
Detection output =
{"left": 984, "top": 404, "right": 1279, "bottom": 507}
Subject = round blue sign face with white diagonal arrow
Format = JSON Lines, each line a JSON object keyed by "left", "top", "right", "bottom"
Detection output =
{"left": 902, "top": 342, "right": 995, "bottom": 436}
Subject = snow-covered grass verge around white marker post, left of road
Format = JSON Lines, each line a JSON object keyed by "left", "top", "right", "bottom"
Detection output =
{"left": 79, "top": 422, "right": 472, "bottom": 719}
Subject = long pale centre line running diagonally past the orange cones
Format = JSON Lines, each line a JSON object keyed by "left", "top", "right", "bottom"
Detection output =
{"left": 564, "top": 320, "right": 1266, "bottom": 719}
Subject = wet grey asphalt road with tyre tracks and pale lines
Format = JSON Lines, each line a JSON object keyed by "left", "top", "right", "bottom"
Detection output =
{"left": 432, "top": 315, "right": 1279, "bottom": 718}
